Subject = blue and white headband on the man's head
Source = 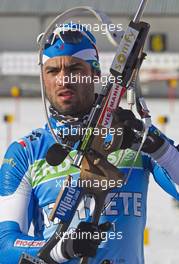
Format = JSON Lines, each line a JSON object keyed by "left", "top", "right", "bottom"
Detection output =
{"left": 43, "top": 23, "right": 100, "bottom": 71}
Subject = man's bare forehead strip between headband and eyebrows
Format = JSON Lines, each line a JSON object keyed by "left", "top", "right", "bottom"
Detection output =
{"left": 44, "top": 56, "right": 88, "bottom": 67}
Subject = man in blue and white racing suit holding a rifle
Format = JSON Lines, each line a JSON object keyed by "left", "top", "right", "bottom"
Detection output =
{"left": 0, "top": 23, "right": 179, "bottom": 264}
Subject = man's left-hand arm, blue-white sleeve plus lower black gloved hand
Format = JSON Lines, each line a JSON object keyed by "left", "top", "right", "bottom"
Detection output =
{"left": 0, "top": 142, "right": 109, "bottom": 264}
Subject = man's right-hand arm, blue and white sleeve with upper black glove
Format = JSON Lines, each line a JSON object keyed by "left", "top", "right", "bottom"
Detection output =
{"left": 114, "top": 108, "right": 179, "bottom": 200}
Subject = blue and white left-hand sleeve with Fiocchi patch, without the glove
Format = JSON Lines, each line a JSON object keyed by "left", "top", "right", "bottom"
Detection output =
{"left": 0, "top": 142, "right": 49, "bottom": 264}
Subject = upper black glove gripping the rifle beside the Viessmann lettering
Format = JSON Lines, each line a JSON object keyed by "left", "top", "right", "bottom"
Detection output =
{"left": 113, "top": 107, "right": 144, "bottom": 149}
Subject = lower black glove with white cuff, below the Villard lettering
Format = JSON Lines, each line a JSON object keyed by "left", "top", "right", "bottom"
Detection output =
{"left": 61, "top": 222, "right": 111, "bottom": 259}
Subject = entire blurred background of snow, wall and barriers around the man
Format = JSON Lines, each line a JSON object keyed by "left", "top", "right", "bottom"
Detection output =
{"left": 0, "top": 0, "right": 179, "bottom": 264}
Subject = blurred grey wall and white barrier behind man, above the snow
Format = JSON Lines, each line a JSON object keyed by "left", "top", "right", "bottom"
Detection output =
{"left": 0, "top": 0, "right": 179, "bottom": 97}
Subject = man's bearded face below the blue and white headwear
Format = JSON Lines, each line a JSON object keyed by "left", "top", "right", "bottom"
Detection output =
{"left": 43, "top": 56, "right": 95, "bottom": 116}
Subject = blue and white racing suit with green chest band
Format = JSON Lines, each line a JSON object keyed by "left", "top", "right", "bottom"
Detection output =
{"left": 0, "top": 118, "right": 178, "bottom": 264}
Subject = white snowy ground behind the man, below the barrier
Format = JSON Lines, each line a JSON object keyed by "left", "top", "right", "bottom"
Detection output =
{"left": 0, "top": 99, "right": 179, "bottom": 264}
